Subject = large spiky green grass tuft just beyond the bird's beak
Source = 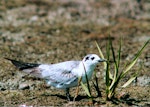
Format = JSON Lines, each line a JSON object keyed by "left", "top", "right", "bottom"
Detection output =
{"left": 97, "top": 36, "right": 150, "bottom": 100}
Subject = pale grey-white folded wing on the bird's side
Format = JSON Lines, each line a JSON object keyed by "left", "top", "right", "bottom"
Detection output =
{"left": 39, "top": 61, "right": 80, "bottom": 87}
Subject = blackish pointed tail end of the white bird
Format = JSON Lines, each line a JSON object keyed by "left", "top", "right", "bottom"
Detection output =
{"left": 5, "top": 58, "right": 40, "bottom": 70}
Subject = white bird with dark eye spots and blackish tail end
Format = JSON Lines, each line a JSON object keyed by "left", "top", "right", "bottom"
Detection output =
{"left": 5, "top": 54, "right": 107, "bottom": 101}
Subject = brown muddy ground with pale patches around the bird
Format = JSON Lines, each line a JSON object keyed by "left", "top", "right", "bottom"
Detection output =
{"left": 0, "top": 0, "right": 150, "bottom": 107}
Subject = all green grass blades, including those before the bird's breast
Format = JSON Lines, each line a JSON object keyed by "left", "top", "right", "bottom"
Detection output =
{"left": 81, "top": 37, "right": 150, "bottom": 102}
